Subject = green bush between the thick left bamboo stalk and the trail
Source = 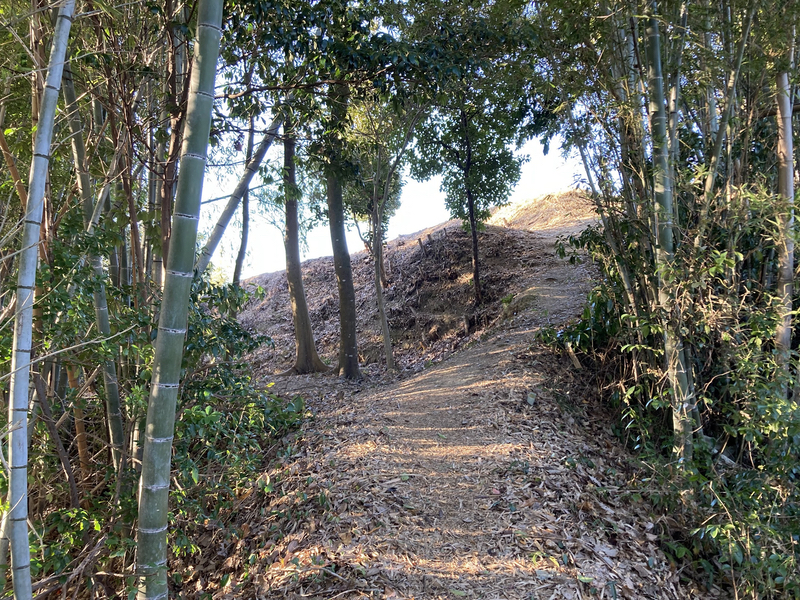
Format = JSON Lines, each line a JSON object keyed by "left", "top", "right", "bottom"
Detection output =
{"left": 172, "top": 280, "right": 306, "bottom": 536}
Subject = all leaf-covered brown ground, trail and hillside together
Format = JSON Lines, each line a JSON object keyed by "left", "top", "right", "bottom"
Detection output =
{"left": 184, "top": 194, "right": 721, "bottom": 600}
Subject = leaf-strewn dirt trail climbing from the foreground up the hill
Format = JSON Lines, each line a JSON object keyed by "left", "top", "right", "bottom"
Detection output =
{"left": 208, "top": 195, "right": 719, "bottom": 599}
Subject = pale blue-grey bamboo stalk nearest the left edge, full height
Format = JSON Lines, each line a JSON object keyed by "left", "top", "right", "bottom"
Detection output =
{"left": 8, "top": 0, "right": 75, "bottom": 600}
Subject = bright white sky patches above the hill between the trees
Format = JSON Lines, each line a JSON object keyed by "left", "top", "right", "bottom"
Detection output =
{"left": 200, "top": 140, "right": 583, "bottom": 278}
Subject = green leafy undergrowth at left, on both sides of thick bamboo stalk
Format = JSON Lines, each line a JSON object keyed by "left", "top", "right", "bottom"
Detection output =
{"left": 0, "top": 280, "right": 306, "bottom": 593}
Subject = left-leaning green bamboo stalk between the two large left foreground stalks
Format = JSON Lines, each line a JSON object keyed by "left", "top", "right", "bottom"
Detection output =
{"left": 63, "top": 64, "right": 125, "bottom": 472}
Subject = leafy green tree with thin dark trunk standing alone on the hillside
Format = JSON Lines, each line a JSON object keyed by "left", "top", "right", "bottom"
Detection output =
{"left": 412, "top": 5, "right": 540, "bottom": 305}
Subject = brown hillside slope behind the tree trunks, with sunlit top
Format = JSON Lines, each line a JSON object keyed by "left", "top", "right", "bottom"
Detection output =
{"left": 241, "top": 192, "right": 593, "bottom": 375}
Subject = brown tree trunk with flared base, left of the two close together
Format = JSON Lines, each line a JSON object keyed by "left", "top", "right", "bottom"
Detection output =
{"left": 283, "top": 133, "right": 330, "bottom": 375}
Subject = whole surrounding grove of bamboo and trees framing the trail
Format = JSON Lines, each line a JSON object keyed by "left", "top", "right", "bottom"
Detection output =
{"left": 0, "top": 0, "right": 800, "bottom": 599}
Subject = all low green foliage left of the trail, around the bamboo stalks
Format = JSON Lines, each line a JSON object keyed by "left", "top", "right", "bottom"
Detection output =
{"left": 0, "top": 268, "right": 307, "bottom": 596}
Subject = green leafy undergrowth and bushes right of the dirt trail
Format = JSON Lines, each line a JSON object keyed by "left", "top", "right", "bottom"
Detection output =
{"left": 541, "top": 192, "right": 800, "bottom": 599}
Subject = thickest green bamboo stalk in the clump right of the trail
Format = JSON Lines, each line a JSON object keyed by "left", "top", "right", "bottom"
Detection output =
{"left": 647, "top": 1, "right": 693, "bottom": 461}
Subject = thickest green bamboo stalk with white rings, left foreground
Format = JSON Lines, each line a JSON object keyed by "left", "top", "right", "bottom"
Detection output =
{"left": 136, "top": 0, "right": 222, "bottom": 600}
